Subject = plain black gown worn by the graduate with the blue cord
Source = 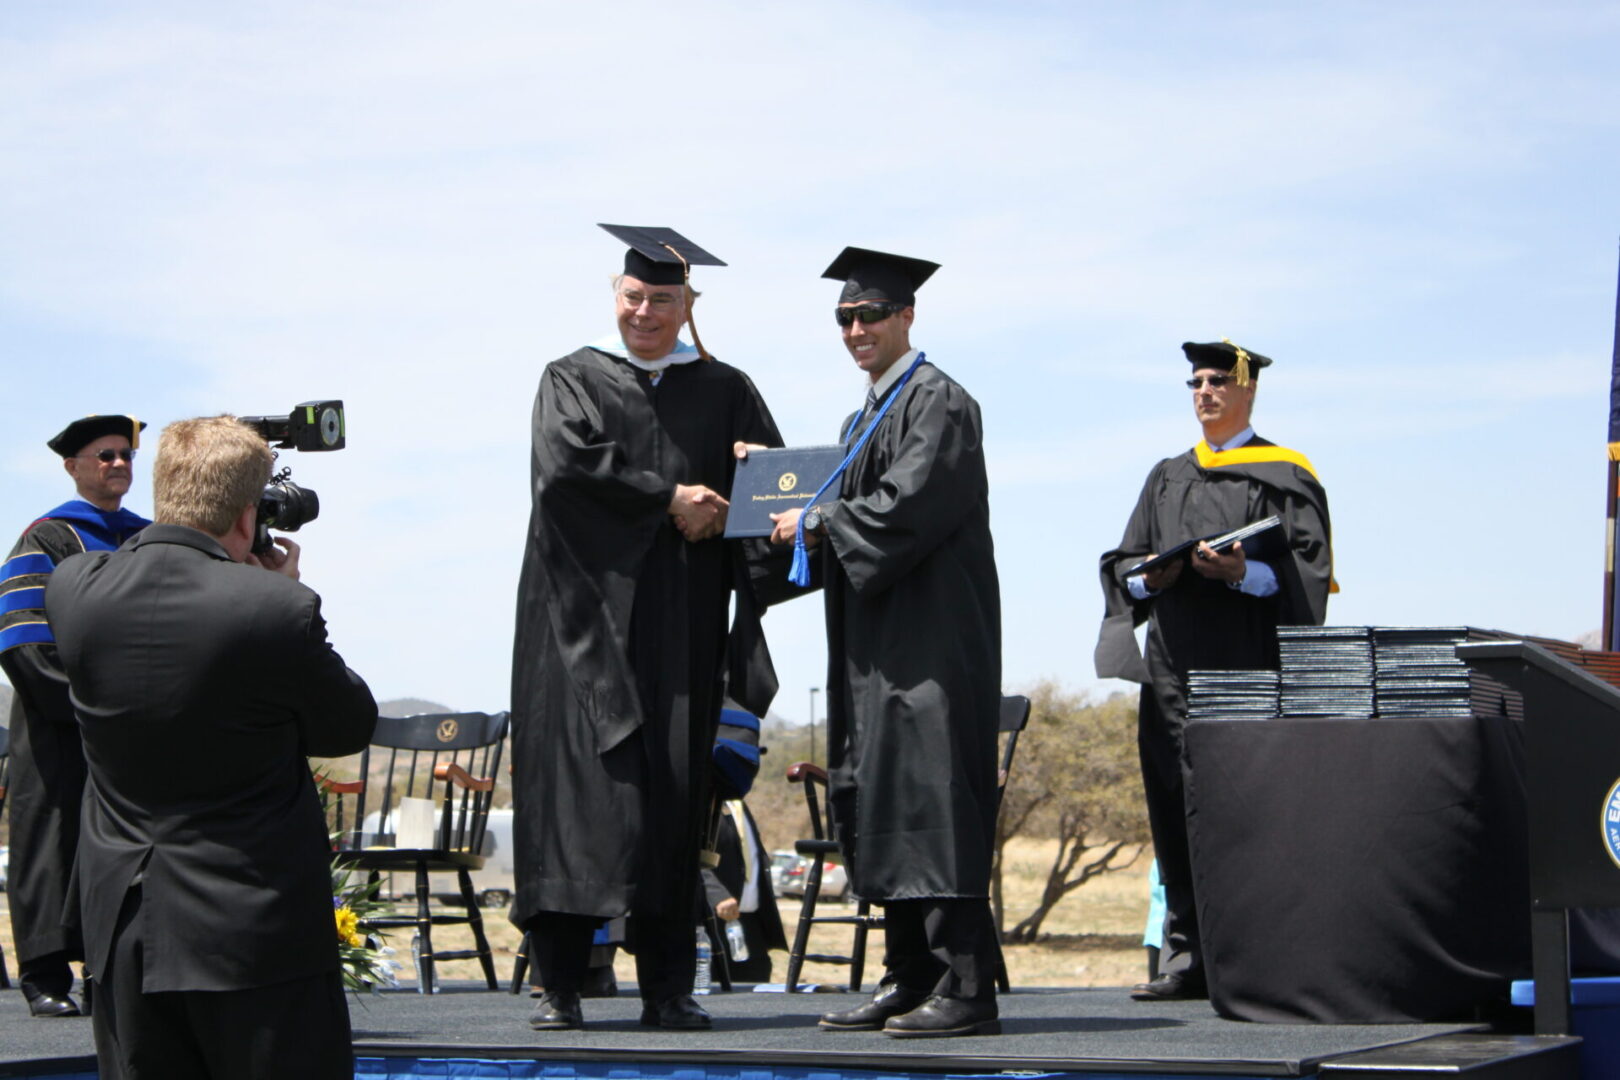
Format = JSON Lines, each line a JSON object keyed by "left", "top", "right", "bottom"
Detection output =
{"left": 818, "top": 364, "right": 1001, "bottom": 900}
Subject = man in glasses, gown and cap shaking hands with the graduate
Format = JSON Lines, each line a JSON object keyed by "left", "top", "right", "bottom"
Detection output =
{"left": 512, "top": 227, "right": 781, "bottom": 1030}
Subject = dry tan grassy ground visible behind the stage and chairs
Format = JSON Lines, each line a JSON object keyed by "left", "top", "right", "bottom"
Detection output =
{"left": 0, "top": 840, "right": 1149, "bottom": 986}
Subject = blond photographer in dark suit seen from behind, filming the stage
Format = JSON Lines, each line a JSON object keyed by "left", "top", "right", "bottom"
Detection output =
{"left": 45, "top": 416, "right": 377, "bottom": 1080}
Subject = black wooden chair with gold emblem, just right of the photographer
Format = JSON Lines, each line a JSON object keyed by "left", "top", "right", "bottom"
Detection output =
{"left": 322, "top": 712, "right": 507, "bottom": 994}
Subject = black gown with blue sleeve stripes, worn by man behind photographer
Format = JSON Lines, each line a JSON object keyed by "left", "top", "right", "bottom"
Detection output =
{"left": 0, "top": 504, "right": 146, "bottom": 963}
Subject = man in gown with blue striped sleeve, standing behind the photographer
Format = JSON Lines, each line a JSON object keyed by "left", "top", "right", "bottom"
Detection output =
{"left": 0, "top": 415, "right": 149, "bottom": 1017}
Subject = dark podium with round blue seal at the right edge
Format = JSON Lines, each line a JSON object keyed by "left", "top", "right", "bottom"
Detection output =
{"left": 1456, "top": 641, "right": 1620, "bottom": 1035}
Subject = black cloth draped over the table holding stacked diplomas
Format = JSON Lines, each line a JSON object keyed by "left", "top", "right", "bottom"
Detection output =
{"left": 1186, "top": 717, "right": 1529, "bottom": 1023}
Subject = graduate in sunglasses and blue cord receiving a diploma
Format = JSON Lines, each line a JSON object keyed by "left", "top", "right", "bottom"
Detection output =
{"left": 773, "top": 248, "right": 1001, "bottom": 1038}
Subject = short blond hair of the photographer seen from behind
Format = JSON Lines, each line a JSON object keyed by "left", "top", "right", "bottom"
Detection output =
{"left": 152, "top": 416, "right": 274, "bottom": 536}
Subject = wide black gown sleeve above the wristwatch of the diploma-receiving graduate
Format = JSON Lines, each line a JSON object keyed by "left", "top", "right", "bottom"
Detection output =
{"left": 825, "top": 379, "right": 988, "bottom": 597}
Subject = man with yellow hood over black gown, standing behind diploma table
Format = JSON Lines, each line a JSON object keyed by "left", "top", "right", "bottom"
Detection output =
{"left": 1097, "top": 342, "right": 1332, "bottom": 1001}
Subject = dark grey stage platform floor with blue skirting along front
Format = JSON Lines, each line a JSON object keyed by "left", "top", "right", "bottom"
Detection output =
{"left": 0, "top": 986, "right": 1580, "bottom": 1080}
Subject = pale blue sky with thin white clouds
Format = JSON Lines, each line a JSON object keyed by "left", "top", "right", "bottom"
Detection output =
{"left": 0, "top": 0, "right": 1620, "bottom": 719}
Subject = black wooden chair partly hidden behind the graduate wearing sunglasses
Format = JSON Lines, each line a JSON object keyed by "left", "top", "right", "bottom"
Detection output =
{"left": 786, "top": 695, "right": 1029, "bottom": 993}
